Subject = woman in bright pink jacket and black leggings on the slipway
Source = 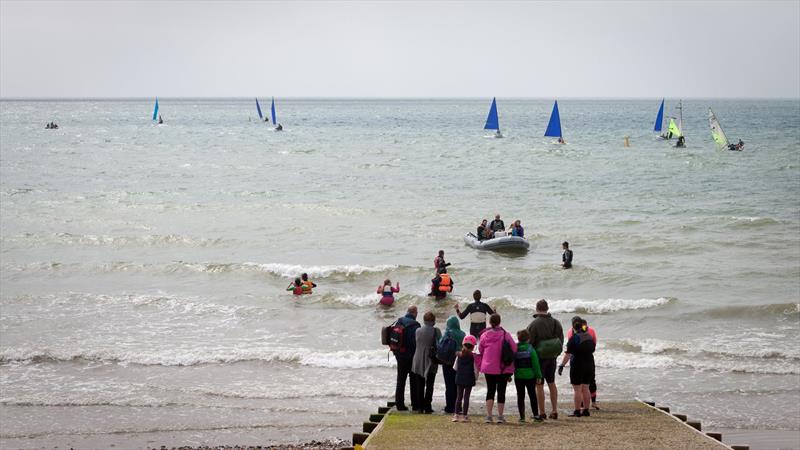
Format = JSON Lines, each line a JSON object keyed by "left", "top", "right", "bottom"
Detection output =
{"left": 478, "top": 314, "right": 517, "bottom": 423}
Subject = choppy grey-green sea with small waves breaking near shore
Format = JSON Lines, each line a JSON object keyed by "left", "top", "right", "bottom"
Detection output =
{"left": 0, "top": 98, "right": 800, "bottom": 448}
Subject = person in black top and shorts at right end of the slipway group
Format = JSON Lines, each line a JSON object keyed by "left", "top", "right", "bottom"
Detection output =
{"left": 558, "top": 317, "right": 596, "bottom": 417}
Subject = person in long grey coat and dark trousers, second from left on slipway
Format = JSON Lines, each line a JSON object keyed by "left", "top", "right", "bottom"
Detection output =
{"left": 411, "top": 311, "right": 442, "bottom": 414}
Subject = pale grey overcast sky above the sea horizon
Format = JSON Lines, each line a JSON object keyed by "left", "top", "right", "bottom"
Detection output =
{"left": 0, "top": 0, "right": 800, "bottom": 98}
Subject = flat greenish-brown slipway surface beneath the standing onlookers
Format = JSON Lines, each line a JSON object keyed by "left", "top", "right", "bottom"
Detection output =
{"left": 346, "top": 400, "right": 749, "bottom": 450}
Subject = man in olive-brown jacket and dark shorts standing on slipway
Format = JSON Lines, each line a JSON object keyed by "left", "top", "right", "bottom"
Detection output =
{"left": 527, "top": 299, "right": 564, "bottom": 420}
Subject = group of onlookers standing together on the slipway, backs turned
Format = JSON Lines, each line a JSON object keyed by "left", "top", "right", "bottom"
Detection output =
{"left": 383, "top": 298, "right": 600, "bottom": 423}
